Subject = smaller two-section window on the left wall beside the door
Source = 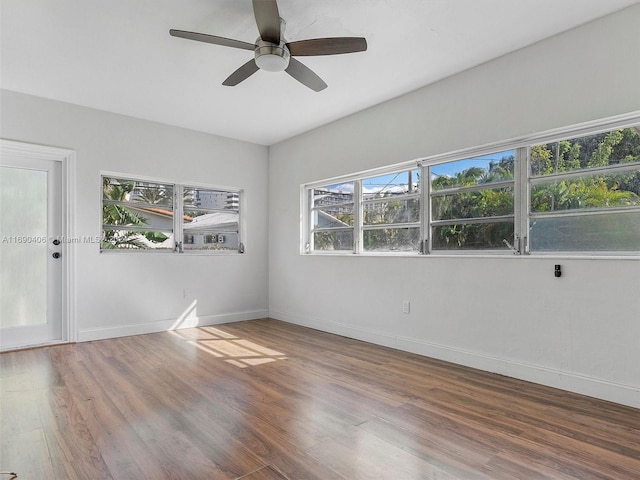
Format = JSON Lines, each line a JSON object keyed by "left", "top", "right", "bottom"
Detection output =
{"left": 101, "top": 175, "right": 244, "bottom": 253}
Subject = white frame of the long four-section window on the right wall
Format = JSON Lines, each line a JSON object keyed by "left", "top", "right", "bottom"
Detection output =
{"left": 300, "top": 111, "right": 640, "bottom": 258}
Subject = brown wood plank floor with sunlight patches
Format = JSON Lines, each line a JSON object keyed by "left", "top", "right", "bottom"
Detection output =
{"left": 0, "top": 320, "right": 640, "bottom": 480}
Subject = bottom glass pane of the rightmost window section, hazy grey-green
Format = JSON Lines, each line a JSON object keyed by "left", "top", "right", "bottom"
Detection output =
{"left": 529, "top": 212, "right": 640, "bottom": 252}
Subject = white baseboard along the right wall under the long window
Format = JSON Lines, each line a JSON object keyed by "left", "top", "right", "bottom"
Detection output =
{"left": 269, "top": 311, "right": 640, "bottom": 408}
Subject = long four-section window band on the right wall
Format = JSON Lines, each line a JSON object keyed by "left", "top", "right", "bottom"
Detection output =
{"left": 302, "top": 117, "right": 640, "bottom": 254}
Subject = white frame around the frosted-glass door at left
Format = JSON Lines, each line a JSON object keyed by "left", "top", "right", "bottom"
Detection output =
{"left": 0, "top": 138, "right": 77, "bottom": 348}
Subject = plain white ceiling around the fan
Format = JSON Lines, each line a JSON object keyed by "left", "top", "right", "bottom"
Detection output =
{"left": 0, "top": 0, "right": 639, "bottom": 145}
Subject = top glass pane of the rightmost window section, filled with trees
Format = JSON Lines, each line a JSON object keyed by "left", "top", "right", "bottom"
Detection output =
{"left": 531, "top": 127, "right": 640, "bottom": 177}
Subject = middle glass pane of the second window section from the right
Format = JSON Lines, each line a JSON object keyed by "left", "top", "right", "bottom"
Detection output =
{"left": 431, "top": 187, "right": 513, "bottom": 220}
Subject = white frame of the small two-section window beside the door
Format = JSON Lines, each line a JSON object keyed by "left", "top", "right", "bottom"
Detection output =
{"left": 99, "top": 171, "right": 246, "bottom": 255}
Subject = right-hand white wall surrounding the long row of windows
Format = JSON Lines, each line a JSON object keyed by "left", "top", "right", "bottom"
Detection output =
{"left": 269, "top": 5, "right": 640, "bottom": 407}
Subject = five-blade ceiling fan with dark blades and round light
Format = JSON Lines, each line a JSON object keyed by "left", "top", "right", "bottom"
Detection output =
{"left": 169, "top": 0, "right": 367, "bottom": 92}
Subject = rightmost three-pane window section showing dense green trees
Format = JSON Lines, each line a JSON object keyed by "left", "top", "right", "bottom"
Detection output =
{"left": 529, "top": 128, "right": 640, "bottom": 252}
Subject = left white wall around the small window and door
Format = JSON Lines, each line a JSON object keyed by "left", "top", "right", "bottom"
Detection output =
{"left": 0, "top": 91, "right": 268, "bottom": 341}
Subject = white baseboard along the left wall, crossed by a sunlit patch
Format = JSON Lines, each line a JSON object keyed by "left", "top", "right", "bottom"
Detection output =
{"left": 78, "top": 310, "right": 269, "bottom": 342}
